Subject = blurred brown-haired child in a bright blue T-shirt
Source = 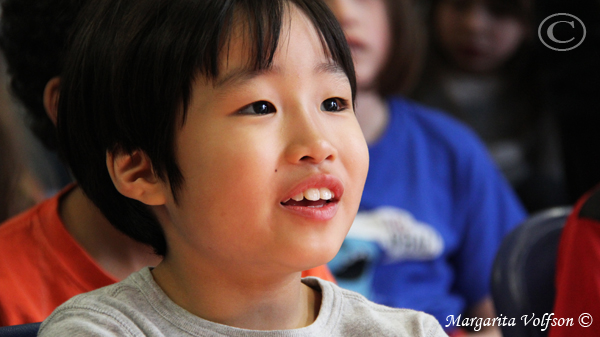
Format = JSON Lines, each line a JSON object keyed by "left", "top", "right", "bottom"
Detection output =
{"left": 326, "top": 0, "right": 525, "bottom": 335}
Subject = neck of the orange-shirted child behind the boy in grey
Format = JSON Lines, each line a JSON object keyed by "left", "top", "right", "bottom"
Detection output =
{"left": 60, "top": 186, "right": 160, "bottom": 280}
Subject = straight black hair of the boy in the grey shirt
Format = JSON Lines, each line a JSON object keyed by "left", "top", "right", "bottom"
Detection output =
{"left": 58, "top": 0, "right": 356, "bottom": 255}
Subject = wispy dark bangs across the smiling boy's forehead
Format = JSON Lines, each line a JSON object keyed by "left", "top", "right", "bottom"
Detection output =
{"left": 192, "top": 0, "right": 356, "bottom": 100}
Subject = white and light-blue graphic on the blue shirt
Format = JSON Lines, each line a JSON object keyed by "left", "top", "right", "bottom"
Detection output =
{"left": 328, "top": 207, "right": 444, "bottom": 297}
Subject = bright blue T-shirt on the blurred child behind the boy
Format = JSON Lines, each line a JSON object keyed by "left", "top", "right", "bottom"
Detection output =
{"left": 329, "top": 97, "right": 526, "bottom": 325}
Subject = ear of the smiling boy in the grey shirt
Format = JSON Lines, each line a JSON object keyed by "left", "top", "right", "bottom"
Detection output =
{"left": 106, "top": 150, "right": 169, "bottom": 206}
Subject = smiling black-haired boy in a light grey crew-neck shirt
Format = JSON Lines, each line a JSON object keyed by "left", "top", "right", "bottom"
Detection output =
{"left": 40, "top": 0, "right": 445, "bottom": 336}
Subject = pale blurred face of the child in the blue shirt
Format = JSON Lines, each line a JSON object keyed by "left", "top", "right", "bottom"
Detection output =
{"left": 325, "top": 0, "right": 391, "bottom": 90}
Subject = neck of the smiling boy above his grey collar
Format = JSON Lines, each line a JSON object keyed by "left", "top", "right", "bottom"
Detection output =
{"left": 152, "top": 256, "right": 321, "bottom": 330}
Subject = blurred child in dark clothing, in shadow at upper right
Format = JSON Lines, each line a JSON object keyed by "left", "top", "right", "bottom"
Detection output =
{"left": 414, "top": 0, "right": 567, "bottom": 211}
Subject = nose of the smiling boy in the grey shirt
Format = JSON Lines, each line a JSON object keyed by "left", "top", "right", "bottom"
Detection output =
{"left": 283, "top": 109, "right": 338, "bottom": 165}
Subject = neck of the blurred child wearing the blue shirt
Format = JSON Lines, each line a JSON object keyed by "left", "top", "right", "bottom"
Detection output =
{"left": 356, "top": 90, "right": 389, "bottom": 144}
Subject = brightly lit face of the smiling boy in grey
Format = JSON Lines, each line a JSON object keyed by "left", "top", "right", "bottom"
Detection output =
{"left": 158, "top": 9, "right": 368, "bottom": 272}
